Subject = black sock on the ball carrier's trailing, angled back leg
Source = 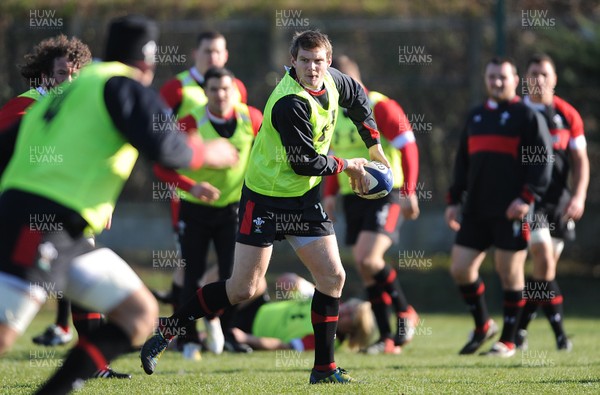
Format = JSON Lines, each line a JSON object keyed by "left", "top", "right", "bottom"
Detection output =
{"left": 164, "top": 281, "right": 231, "bottom": 339}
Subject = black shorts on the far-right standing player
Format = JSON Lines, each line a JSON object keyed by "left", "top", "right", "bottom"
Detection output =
{"left": 527, "top": 189, "right": 575, "bottom": 241}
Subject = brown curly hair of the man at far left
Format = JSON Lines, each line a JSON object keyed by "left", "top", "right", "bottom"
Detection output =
{"left": 19, "top": 34, "right": 92, "bottom": 80}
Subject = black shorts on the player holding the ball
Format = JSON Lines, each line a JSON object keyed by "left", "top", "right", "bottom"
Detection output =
{"left": 237, "top": 193, "right": 335, "bottom": 247}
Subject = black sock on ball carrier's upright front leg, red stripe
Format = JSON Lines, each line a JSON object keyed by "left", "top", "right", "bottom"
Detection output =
{"left": 310, "top": 289, "right": 340, "bottom": 372}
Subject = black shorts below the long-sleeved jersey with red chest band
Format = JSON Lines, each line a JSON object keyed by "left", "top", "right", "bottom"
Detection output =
{"left": 455, "top": 215, "right": 529, "bottom": 251}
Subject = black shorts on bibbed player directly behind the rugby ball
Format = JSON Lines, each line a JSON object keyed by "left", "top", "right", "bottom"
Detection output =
{"left": 342, "top": 189, "right": 402, "bottom": 245}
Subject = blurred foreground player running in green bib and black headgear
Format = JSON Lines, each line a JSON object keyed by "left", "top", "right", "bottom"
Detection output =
{"left": 0, "top": 16, "right": 237, "bottom": 394}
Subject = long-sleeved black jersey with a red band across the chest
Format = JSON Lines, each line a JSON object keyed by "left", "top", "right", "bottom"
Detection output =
{"left": 447, "top": 97, "right": 552, "bottom": 217}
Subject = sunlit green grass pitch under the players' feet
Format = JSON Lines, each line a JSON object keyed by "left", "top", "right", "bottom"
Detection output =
{"left": 0, "top": 302, "right": 600, "bottom": 395}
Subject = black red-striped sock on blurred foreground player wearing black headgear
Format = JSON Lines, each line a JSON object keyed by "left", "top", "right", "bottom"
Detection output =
{"left": 38, "top": 323, "right": 131, "bottom": 394}
